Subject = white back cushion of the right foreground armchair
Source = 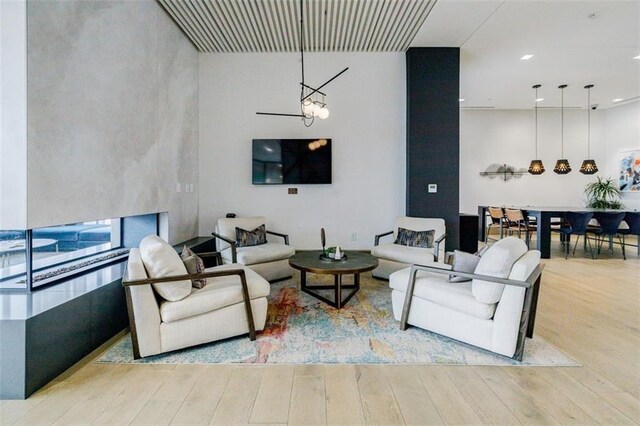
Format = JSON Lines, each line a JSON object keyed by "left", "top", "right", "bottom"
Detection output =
{"left": 472, "top": 237, "right": 527, "bottom": 303}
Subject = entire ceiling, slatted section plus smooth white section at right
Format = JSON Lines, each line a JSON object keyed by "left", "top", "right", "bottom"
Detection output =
{"left": 161, "top": 0, "right": 640, "bottom": 109}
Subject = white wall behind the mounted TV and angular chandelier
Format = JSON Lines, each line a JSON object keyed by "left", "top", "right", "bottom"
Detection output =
{"left": 199, "top": 53, "right": 406, "bottom": 248}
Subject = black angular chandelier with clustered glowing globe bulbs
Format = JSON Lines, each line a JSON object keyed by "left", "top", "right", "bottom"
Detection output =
{"left": 256, "top": 0, "right": 349, "bottom": 127}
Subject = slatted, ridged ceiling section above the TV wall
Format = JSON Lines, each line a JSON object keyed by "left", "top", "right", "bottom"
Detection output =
{"left": 158, "top": 0, "right": 437, "bottom": 52}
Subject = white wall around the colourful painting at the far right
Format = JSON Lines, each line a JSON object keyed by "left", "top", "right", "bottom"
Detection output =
{"left": 602, "top": 102, "right": 640, "bottom": 210}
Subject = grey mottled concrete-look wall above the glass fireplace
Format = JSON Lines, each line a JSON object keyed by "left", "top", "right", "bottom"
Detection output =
{"left": 27, "top": 1, "right": 198, "bottom": 242}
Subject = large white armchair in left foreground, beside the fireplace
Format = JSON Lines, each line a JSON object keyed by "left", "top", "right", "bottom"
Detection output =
{"left": 122, "top": 235, "right": 271, "bottom": 359}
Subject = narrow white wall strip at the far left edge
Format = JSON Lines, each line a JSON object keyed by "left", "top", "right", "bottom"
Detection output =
{"left": 0, "top": 0, "right": 27, "bottom": 229}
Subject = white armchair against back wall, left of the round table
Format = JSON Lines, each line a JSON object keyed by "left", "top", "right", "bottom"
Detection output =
{"left": 212, "top": 216, "right": 296, "bottom": 281}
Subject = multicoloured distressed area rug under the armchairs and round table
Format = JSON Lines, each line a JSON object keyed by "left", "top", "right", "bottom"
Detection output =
{"left": 96, "top": 274, "right": 578, "bottom": 366}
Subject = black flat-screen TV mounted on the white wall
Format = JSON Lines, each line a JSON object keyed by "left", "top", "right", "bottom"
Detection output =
{"left": 253, "top": 139, "right": 331, "bottom": 185}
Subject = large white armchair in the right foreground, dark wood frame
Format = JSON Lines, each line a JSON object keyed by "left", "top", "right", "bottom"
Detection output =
{"left": 389, "top": 237, "right": 542, "bottom": 361}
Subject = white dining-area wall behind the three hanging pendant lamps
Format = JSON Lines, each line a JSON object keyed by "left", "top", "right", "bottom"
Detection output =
{"left": 460, "top": 109, "right": 612, "bottom": 213}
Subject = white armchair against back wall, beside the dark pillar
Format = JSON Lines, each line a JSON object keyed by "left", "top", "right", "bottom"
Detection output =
{"left": 371, "top": 216, "right": 446, "bottom": 279}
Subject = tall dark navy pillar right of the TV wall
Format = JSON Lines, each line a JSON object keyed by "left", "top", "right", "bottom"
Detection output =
{"left": 406, "top": 47, "right": 460, "bottom": 250}
